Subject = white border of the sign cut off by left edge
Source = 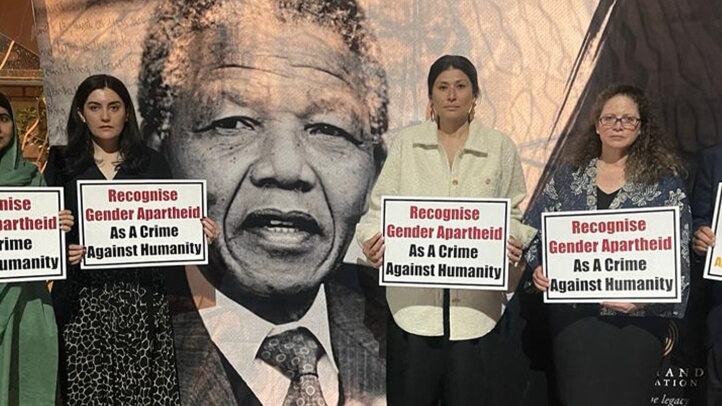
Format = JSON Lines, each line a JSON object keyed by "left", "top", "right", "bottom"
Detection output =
{"left": 0, "top": 186, "right": 68, "bottom": 283}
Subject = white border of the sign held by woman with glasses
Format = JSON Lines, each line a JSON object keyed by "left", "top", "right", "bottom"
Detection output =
{"left": 542, "top": 206, "right": 682, "bottom": 303}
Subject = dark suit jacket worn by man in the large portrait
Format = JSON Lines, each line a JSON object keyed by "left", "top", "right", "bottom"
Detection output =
{"left": 167, "top": 265, "right": 386, "bottom": 406}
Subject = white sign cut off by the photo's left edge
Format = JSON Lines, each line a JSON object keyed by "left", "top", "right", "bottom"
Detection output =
{"left": 0, "top": 187, "right": 67, "bottom": 283}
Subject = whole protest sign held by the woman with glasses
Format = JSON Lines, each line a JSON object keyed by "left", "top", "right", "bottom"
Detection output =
{"left": 542, "top": 207, "right": 682, "bottom": 303}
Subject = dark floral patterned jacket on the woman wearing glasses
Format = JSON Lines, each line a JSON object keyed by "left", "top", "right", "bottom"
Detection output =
{"left": 524, "top": 158, "right": 692, "bottom": 318}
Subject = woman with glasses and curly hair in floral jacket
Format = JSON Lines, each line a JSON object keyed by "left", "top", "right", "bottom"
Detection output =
{"left": 525, "top": 85, "right": 691, "bottom": 406}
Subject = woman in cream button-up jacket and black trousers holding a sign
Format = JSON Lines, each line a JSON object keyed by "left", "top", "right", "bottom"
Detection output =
{"left": 356, "top": 55, "right": 533, "bottom": 406}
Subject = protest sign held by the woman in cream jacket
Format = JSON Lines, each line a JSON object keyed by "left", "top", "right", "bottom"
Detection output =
{"left": 379, "top": 196, "right": 510, "bottom": 290}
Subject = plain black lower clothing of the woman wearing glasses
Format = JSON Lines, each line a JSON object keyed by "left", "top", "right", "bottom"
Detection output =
{"left": 552, "top": 314, "right": 669, "bottom": 406}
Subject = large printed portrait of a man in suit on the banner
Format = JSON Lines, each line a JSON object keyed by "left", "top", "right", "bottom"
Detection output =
{"left": 138, "top": 0, "right": 388, "bottom": 405}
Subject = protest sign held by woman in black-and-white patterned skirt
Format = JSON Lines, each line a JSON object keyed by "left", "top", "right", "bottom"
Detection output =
{"left": 78, "top": 180, "right": 208, "bottom": 269}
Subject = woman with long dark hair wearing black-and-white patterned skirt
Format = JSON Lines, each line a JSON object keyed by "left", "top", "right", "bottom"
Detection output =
{"left": 45, "top": 75, "right": 217, "bottom": 405}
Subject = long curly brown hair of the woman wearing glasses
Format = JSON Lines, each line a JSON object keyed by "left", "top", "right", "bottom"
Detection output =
{"left": 569, "top": 84, "right": 686, "bottom": 184}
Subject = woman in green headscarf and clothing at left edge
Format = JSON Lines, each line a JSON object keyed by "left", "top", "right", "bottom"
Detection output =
{"left": 0, "top": 93, "right": 73, "bottom": 406}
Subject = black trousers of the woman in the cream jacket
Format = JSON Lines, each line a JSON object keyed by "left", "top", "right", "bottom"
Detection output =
{"left": 386, "top": 315, "right": 497, "bottom": 406}
